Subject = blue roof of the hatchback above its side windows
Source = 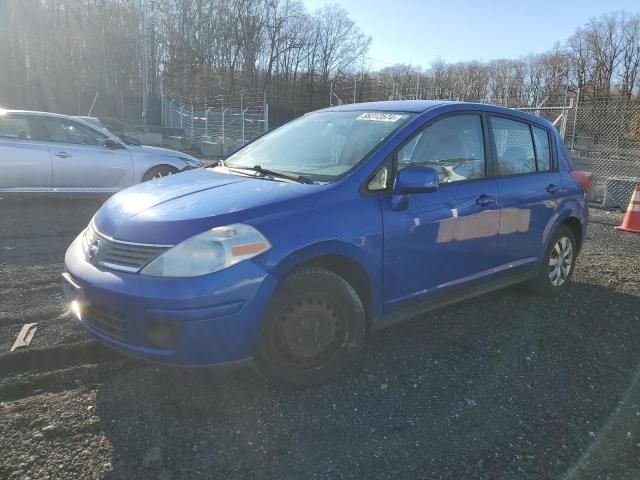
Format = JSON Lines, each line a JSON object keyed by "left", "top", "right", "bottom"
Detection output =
{"left": 320, "top": 100, "right": 553, "bottom": 128}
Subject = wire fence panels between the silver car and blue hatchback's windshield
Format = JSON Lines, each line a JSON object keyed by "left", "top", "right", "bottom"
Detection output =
{"left": 161, "top": 93, "right": 269, "bottom": 157}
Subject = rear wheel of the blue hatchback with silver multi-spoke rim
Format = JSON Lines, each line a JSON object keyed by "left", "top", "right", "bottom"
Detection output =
{"left": 529, "top": 225, "right": 578, "bottom": 295}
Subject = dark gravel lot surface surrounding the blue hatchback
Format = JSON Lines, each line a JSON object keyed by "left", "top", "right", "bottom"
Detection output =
{"left": 0, "top": 204, "right": 640, "bottom": 480}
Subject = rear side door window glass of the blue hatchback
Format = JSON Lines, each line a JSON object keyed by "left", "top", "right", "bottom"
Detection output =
{"left": 490, "top": 117, "right": 536, "bottom": 175}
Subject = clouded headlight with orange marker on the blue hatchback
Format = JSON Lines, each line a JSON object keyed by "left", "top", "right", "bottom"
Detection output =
{"left": 140, "top": 223, "right": 271, "bottom": 277}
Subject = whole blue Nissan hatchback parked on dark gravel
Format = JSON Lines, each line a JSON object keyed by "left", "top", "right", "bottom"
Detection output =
{"left": 63, "top": 101, "right": 588, "bottom": 386}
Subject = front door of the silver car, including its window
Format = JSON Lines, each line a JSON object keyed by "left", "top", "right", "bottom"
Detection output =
{"left": 43, "top": 116, "right": 133, "bottom": 192}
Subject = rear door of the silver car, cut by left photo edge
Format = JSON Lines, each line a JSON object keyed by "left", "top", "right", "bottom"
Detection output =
{"left": 0, "top": 113, "right": 52, "bottom": 192}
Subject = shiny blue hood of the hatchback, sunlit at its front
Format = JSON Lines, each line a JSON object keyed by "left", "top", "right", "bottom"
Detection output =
{"left": 94, "top": 169, "right": 324, "bottom": 245}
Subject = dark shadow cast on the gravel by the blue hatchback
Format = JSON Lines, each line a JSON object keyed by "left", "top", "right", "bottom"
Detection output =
{"left": 96, "top": 283, "right": 640, "bottom": 479}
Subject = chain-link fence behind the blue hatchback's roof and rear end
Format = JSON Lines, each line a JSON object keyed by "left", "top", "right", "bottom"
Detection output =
{"left": 329, "top": 82, "right": 640, "bottom": 208}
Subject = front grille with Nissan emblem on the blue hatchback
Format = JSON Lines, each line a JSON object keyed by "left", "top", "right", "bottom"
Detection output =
{"left": 83, "top": 222, "right": 171, "bottom": 272}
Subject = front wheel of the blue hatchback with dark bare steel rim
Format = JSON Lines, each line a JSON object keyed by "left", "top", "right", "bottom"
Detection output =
{"left": 255, "top": 267, "right": 367, "bottom": 388}
